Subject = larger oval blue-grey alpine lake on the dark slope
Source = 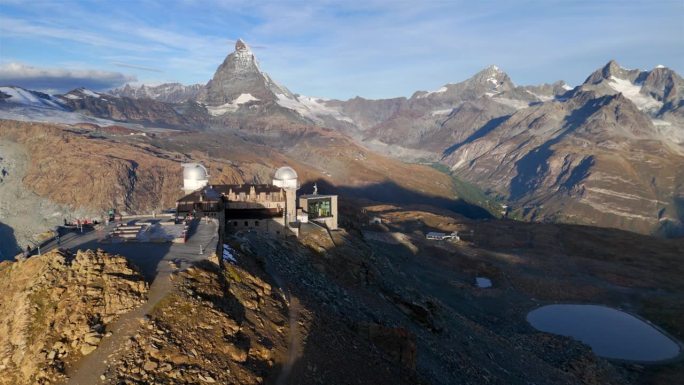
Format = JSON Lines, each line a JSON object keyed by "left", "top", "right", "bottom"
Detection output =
{"left": 527, "top": 304, "right": 680, "bottom": 362}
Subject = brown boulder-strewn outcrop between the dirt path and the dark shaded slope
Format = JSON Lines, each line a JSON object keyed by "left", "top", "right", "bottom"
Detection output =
{"left": 104, "top": 262, "right": 288, "bottom": 385}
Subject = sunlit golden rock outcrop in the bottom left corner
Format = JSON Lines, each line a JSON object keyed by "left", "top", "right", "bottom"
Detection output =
{"left": 0, "top": 250, "right": 148, "bottom": 385}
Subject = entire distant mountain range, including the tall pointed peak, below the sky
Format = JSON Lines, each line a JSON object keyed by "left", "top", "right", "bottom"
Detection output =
{"left": 0, "top": 40, "right": 684, "bottom": 236}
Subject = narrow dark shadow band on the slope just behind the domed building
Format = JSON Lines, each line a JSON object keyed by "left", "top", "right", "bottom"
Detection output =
{"left": 300, "top": 180, "right": 492, "bottom": 219}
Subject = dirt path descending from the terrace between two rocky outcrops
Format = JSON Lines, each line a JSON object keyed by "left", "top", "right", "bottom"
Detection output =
{"left": 66, "top": 219, "right": 218, "bottom": 385}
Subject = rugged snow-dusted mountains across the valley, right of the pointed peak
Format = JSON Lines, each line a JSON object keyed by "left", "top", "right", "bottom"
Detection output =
{"left": 316, "top": 61, "right": 684, "bottom": 236}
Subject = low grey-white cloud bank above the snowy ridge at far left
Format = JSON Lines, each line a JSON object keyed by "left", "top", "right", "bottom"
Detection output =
{"left": 0, "top": 62, "right": 137, "bottom": 92}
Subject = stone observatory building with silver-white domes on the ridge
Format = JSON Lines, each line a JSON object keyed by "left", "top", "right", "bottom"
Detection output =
{"left": 176, "top": 165, "right": 337, "bottom": 236}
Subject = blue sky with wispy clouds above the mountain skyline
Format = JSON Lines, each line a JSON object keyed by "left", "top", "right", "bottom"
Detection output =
{"left": 0, "top": 0, "right": 684, "bottom": 99}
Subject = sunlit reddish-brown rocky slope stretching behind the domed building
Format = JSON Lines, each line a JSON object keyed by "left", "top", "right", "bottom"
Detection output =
{"left": 0, "top": 120, "right": 455, "bottom": 218}
